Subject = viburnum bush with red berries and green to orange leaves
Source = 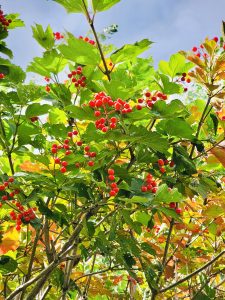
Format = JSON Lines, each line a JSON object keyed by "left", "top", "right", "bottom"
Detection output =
{"left": 0, "top": 0, "right": 225, "bottom": 300}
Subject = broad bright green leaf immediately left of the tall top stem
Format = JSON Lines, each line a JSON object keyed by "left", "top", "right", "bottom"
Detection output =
{"left": 58, "top": 33, "right": 101, "bottom": 65}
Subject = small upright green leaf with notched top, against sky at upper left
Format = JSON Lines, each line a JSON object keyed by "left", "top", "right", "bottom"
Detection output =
{"left": 32, "top": 24, "right": 55, "bottom": 50}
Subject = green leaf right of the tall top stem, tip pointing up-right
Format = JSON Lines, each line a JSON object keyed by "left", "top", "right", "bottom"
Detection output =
{"left": 110, "top": 39, "right": 152, "bottom": 63}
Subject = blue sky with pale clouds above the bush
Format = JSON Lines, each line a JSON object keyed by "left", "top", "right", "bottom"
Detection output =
{"left": 1, "top": 0, "right": 225, "bottom": 68}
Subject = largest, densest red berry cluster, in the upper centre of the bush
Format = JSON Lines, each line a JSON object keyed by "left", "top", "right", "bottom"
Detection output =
{"left": 89, "top": 92, "right": 132, "bottom": 132}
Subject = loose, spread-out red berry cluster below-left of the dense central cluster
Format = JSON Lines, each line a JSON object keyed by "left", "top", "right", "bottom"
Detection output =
{"left": 51, "top": 130, "right": 96, "bottom": 173}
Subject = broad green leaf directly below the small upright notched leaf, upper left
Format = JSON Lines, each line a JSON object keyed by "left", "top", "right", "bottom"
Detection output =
{"left": 27, "top": 49, "right": 67, "bottom": 77}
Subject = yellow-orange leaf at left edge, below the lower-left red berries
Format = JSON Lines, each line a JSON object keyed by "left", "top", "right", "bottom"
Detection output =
{"left": 0, "top": 228, "right": 20, "bottom": 255}
